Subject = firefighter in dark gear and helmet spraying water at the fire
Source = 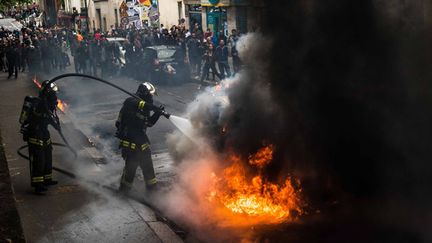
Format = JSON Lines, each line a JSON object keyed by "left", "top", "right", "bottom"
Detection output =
{"left": 116, "top": 82, "right": 168, "bottom": 193}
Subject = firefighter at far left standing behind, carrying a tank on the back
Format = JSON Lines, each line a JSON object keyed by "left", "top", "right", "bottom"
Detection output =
{"left": 19, "top": 81, "right": 60, "bottom": 195}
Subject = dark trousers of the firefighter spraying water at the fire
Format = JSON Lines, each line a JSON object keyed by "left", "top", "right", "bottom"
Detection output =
{"left": 120, "top": 148, "right": 157, "bottom": 191}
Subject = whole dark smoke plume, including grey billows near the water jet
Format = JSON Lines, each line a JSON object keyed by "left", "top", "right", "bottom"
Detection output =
{"left": 165, "top": 0, "right": 432, "bottom": 242}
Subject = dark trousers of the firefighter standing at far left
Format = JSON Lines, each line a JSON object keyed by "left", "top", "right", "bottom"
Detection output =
{"left": 29, "top": 143, "right": 52, "bottom": 187}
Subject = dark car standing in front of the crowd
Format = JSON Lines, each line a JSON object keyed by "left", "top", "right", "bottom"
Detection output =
{"left": 142, "top": 45, "right": 190, "bottom": 84}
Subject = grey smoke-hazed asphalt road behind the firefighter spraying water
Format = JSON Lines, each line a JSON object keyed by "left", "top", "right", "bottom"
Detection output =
{"left": 46, "top": 69, "right": 199, "bottom": 189}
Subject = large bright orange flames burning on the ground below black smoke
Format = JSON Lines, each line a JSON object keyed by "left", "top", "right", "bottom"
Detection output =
{"left": 207, "top": 145, "right": 302, "bottom": 224}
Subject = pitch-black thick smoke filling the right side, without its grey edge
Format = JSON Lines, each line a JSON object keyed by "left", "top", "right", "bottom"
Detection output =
{"left": 253, "top": 0, "right": 432, "bottom": 240}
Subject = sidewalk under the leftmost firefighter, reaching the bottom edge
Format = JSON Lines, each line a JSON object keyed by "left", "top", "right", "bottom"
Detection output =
{"left": 0, "top": 73, "right": 181, "bottom": 242}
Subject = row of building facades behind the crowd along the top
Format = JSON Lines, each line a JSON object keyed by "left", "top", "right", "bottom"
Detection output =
{"left": 39, "top": 0, "right": 265, "bottom": 35}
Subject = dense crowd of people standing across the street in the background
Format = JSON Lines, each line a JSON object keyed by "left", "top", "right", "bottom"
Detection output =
{"left": 0, "top": 15, "right": 241, "bottom": 82}
